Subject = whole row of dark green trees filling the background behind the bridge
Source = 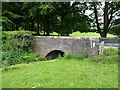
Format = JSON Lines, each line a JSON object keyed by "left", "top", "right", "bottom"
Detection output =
{"left": 0, "top": 2, "right": 120, "bottom": 37}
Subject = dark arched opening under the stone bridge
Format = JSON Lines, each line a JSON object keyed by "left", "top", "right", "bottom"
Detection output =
{"left": 46, "top": 50, "right": 64, "bottom": 60}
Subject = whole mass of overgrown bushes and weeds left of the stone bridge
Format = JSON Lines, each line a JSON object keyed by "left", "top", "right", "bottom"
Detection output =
{"left": 2, "top": 31, "right": 44, "bottom": 67}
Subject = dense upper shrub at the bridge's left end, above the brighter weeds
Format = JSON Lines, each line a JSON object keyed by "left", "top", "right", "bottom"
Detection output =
{"left": 2, "top": 31, "right": 34, "bottom": 51}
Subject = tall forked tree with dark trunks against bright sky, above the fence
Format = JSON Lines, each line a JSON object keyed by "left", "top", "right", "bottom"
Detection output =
{"left": 89, "top": 2, "right": 120, "bottom": 37}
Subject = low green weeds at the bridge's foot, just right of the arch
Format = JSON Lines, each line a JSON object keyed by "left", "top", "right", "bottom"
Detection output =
{"left": 64, "top": 52, "right": 86, "bottom": 60}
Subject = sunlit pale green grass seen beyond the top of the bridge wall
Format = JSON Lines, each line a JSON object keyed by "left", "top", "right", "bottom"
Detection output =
{"left": 50, "top": 32, "right": 118, "bottom": 37}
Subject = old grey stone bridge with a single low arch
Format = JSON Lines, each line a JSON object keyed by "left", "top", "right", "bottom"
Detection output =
{"left": 33, "top": 36, "right": 99, "bottom": 59}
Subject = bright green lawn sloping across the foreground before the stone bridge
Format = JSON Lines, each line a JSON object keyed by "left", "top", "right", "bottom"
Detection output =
{"left": 2, "top": 58, "right": 118, "bottom": 88}
